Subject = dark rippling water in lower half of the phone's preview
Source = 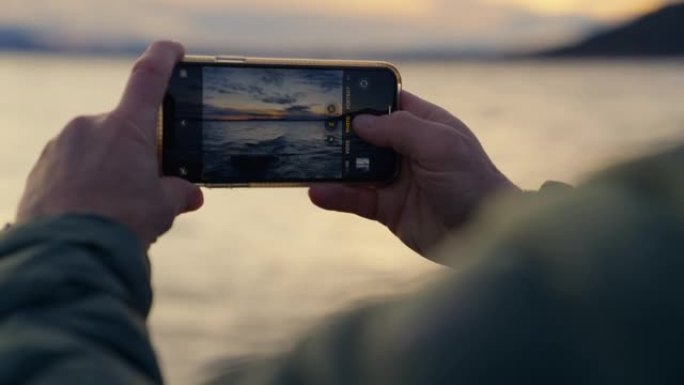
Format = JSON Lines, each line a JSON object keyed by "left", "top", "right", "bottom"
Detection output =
{"left": 203, "top": 121, "right": 342, "bottom": 182}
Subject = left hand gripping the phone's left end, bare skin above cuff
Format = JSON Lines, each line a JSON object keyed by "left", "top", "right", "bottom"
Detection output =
{"left": 16, "top": 42, "right": 203, "bottom": 247}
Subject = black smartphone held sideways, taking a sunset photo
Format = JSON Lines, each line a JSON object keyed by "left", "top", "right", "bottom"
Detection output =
{"left": 157, "top": 56, "right": 401, "bottom": 187}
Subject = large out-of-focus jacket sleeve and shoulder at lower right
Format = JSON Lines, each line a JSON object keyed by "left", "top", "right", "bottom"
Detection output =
{"left": 208, "top": 149, "right": 684, "bottom": 385}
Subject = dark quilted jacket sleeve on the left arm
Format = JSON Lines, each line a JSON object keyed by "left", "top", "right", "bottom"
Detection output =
{"left": 0, "top": 215, "right": 162, "bottom": 385}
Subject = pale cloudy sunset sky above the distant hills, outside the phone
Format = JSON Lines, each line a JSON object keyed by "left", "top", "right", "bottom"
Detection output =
{"left": 0, "top": 0, "right": 667, "bottom": 53}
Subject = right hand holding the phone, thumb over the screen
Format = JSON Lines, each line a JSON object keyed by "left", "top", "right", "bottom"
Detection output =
{"left": 309, "top": 92, "right": 518, "bottom": 255}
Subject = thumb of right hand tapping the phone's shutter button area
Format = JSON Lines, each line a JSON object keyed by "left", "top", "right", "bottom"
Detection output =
{"left": 353, "top": 111, "right": 453, "bottom": 158}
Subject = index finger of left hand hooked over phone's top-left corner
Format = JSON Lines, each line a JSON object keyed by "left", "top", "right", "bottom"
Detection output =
{"left": 116, "top": 41, "right": 185, "bottom": 127}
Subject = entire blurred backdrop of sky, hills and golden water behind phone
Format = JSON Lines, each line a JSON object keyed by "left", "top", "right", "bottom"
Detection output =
{"left": 0, "top": 0, "right": 684, "bottom": 384}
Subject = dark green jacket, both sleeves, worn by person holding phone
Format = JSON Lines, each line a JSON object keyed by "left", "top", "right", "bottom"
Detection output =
{"left": 0, "top": 148, "right": 684, "bottom": 385}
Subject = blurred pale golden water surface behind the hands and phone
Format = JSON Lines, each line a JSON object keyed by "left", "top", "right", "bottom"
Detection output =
{"left": 0, "top": 54, "right": 684, "bottom": 385}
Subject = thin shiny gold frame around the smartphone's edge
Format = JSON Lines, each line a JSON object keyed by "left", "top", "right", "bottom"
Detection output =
{"left": 156, "top": 55, "right": 402, "bottom": 188}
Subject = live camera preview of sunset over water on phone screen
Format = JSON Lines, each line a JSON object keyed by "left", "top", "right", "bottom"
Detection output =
{"left": 202, "top": 67, "right": 343, "bottom": 180}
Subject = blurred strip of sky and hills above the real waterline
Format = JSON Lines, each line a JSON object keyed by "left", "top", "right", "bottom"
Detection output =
{"left": 0, "top": 0, "right": 684, "bottom": 59}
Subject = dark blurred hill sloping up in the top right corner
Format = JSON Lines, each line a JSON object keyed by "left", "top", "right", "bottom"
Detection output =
{"left": 540, "top": 3, "right": 684, "bottom": 57}
